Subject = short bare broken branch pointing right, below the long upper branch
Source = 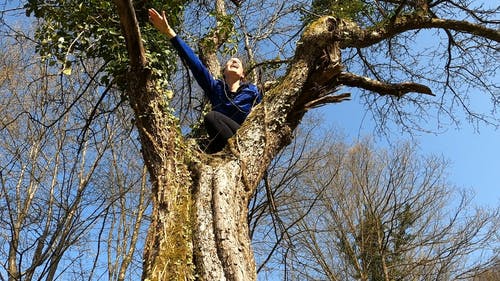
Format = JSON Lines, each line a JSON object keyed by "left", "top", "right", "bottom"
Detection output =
{"left": 338, "top": 73, "right": 434, "bottom": 97}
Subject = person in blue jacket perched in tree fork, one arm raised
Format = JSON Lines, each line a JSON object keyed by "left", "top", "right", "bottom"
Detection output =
{"left": 149, "top": 9, "right": 262, "bottom": 153}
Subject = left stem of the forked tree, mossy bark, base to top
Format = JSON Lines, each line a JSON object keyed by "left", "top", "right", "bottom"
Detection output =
{"left": 115, "top": 0, "right": 194, "bottom": 280}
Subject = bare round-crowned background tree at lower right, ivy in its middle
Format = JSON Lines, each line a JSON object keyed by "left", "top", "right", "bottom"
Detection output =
{"left": 266, "top": 137, "right": 500, "bottom": 280}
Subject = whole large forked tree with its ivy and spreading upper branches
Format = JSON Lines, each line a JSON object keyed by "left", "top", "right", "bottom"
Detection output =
{"left": 0, "top": 0, "right": 500, "bottom": 280}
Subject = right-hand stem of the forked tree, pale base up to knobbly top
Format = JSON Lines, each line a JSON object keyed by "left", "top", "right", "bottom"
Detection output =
{"left": 188, "top": 16, "right": 348, "bottom": 281}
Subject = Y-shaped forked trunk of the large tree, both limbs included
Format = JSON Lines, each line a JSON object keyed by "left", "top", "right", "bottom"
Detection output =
{"left": 115, "top": 0, "right": 341, "bottom": 276}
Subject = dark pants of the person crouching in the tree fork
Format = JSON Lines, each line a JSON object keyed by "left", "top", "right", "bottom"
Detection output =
{"left": 204, "top": 111, "right": 240, "bottom": 153}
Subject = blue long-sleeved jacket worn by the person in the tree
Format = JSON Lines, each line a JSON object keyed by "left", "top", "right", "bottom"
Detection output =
{"left": 170, "top": 36, "right": 262, "bottom": 124}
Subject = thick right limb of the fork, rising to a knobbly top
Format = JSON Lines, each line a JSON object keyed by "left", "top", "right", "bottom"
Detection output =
{"left": 229, "top": 17, "right": 342, "bottom": 187}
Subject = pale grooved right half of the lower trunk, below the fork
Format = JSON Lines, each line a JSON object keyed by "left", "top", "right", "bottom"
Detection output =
{"left": 193, "top": 158, "right": 256, "bottom": 280}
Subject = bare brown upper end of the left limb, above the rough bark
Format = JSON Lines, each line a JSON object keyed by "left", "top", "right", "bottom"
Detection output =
{"left": 115, "top": 0, "right": 146, "bottom": 69}
